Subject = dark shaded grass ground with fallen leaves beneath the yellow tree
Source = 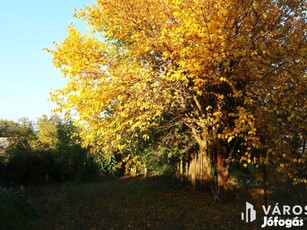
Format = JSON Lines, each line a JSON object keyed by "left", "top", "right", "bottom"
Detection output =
{"left": 15, "top": 177, "right": 306, "bottom": 230}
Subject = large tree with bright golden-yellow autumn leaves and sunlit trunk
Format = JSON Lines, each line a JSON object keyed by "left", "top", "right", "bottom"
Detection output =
{"left": 49, "top": 0, "right": 307, "bottom": 199}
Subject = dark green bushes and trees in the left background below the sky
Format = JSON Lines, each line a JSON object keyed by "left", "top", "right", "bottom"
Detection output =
{"left": 0, "top": 115, "right": 108, "bottom": 186}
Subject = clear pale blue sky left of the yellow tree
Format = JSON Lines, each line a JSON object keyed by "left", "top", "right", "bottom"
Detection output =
{"left": 0, "top": 0, "right": 95, "bottom": 121}
